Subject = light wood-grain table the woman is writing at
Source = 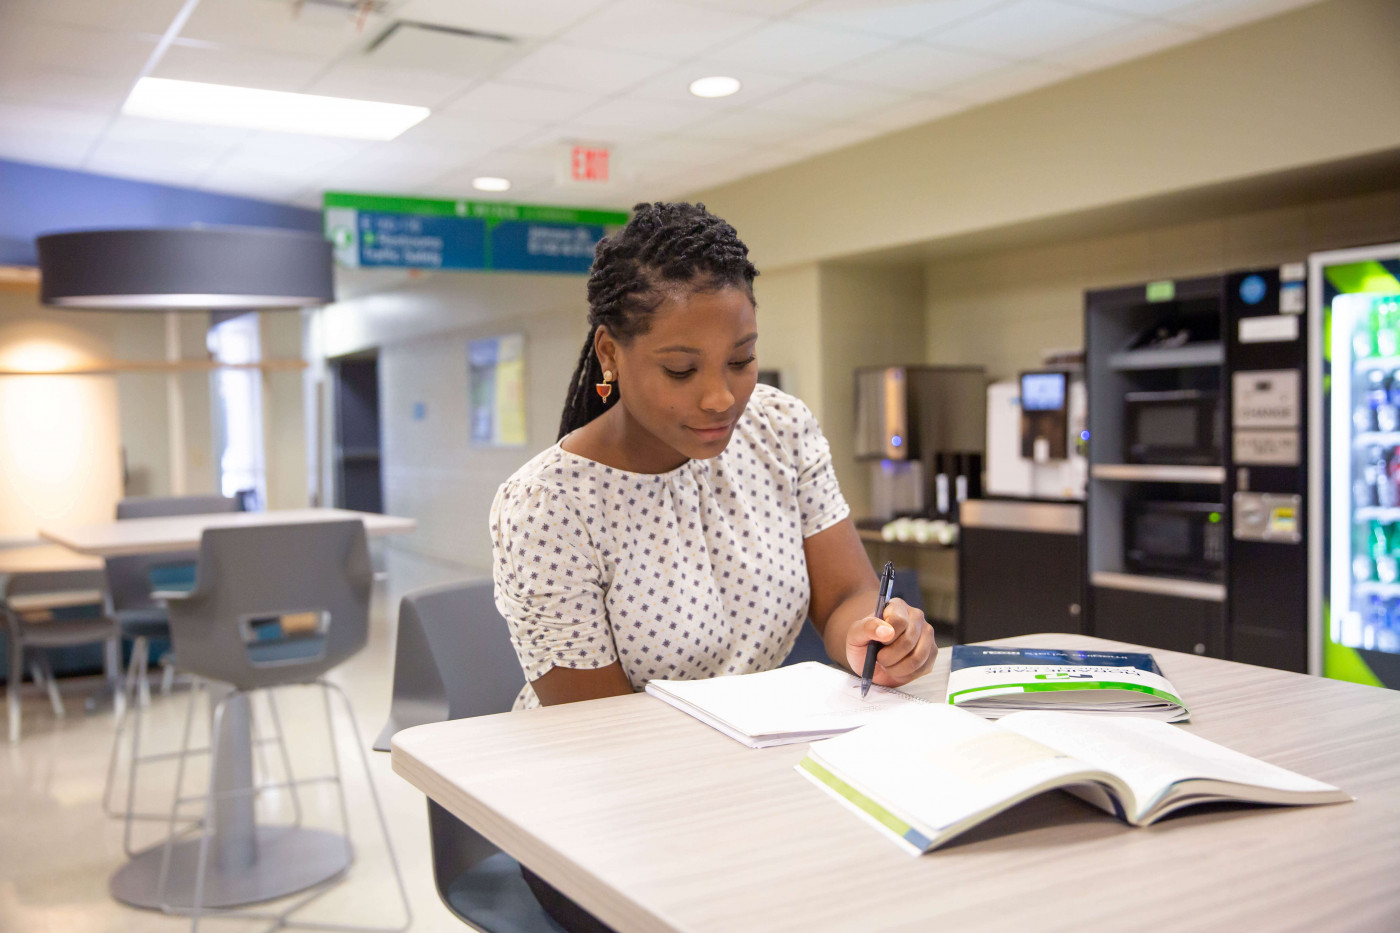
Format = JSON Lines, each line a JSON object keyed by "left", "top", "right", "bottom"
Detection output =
{"left": 393, "top": 635, "right": 1400, "bottom": 933}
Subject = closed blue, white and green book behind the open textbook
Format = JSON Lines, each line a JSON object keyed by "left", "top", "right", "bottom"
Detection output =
{"left": 948, "top": 644, "right": 1190, "bottom": 723}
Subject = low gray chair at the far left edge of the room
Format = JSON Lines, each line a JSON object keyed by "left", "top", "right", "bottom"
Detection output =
{"left": 0, "top": 570, "right": 125, "bottom": 742}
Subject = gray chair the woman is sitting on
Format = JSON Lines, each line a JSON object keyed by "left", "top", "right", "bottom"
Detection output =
{"left": 375, "top": 580, "right": 563, "bottom": 933}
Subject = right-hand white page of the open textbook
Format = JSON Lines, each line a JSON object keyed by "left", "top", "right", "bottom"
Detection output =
{"left": 1001, "top": 712, "right": 1336, "bottom": 815}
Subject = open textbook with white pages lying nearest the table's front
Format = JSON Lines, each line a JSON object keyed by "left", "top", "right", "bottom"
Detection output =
{"left": 797, "top": 705, "right": 1351, "bottom": 855}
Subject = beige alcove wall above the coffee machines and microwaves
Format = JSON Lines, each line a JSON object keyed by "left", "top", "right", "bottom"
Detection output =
{"left": 924, "top": 189, "right": 1400, "bottom": 378}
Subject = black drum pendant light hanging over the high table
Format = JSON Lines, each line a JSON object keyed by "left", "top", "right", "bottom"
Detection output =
{"left": 36, "top": 227, "right": 335, "bottom": 311}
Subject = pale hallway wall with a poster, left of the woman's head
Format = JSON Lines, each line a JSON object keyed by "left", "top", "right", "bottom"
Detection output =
{"left": 314, "top": 264, "right": 588, "bottom": 573}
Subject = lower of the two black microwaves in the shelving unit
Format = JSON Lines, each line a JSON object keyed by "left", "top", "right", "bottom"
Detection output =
{"left": 1123, "top": 502, "right": 1225, "bottom": 580}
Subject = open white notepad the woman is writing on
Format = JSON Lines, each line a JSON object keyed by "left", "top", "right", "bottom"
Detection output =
{"left": 647, "top": 661, "right": 928, "bottom": 748}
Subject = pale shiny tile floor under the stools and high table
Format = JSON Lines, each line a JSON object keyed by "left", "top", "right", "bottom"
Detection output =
{"left": 0, "top": 548, "right": 481, "bottom": 933}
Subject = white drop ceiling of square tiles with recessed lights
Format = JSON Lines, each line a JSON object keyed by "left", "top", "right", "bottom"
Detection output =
{"left": 0, "top": 0, "right": 1313, "bottom": 207}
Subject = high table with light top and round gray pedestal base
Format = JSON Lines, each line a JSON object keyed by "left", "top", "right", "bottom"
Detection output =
{"left": 39, "top": 509, "right": 417, "bottom": 909}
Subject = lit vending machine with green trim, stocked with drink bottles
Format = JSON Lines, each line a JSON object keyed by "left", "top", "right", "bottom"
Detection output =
{"left": 1308, "top": 244, "right": 1400, "bottom": 688}
